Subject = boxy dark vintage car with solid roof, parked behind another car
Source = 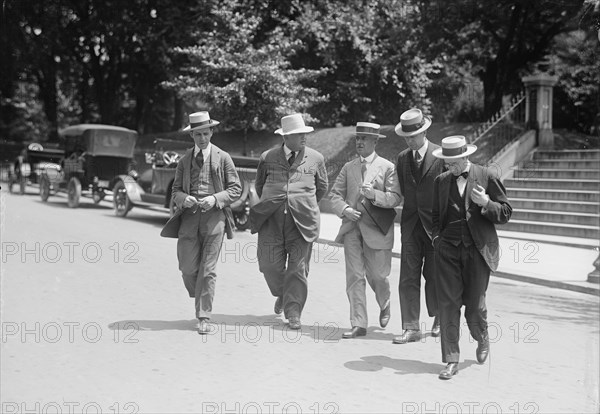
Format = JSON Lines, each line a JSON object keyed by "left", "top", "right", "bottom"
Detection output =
{"left": 40, "top": 124, "right": 138, "bottom": 208}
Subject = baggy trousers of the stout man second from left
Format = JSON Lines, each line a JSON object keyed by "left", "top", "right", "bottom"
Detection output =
{"left": 256, "top": 205, "right": 312, "bottom": 319}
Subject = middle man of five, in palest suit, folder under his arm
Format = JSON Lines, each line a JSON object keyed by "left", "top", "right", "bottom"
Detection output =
{"left": 331, "top": 122, "right": 400, "bottom": 338}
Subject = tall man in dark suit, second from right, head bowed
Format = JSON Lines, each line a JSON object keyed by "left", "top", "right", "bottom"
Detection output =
{"left": 393, "top": 109, "right": 444, "bottom": 344}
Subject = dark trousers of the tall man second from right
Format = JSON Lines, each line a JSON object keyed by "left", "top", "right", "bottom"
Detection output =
{"left": 398, "top": 220, "right": 438, "bottom": 329}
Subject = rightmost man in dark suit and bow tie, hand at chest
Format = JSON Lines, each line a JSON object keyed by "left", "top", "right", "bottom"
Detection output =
{"left": 432, "top": 136, "right": 512, "bottom": 379}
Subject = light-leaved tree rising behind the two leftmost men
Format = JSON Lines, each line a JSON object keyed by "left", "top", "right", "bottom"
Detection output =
{"left": 165, "top": 0, "right": 323, "bottom": 155}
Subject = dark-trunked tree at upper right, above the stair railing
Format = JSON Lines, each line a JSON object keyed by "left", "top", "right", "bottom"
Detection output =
{"left": 412, "top": 0, "right": 583, "bottom": 116}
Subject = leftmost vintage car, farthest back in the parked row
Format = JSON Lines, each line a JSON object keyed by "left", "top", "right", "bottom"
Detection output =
{"left": 8, "top": 142, "right": 65, "bottom": 194}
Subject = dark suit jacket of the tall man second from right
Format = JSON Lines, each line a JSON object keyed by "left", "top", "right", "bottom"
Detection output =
{"left": 396, "top": 141, "right": 444, "bottom": 243}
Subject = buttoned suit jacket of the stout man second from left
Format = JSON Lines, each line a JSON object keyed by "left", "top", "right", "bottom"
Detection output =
{"left": 250, "top": 145, "right": 328, "bottom": 242}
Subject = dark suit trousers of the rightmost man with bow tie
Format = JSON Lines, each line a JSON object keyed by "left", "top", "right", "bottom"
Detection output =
{"left": 435, "top": 236, "right": 490, "bottom": 363}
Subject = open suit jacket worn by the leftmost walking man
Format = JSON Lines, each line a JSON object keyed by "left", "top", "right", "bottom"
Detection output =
{"left": 165, "top": 144, "right": 242, "bottom": 239}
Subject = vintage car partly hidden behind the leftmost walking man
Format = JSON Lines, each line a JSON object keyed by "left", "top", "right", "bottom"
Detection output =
{"left": 113, "top": 139, "right": 258, "bottom": 230}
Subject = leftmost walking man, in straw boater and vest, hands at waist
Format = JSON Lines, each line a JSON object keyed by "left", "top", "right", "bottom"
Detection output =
{"left": 173, "top": 112, "right": 242, "bottom": 334}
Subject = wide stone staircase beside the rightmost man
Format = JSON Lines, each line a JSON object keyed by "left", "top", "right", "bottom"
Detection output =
{"left": 498, "top": 150, "right": 600, "bottom": 241}
